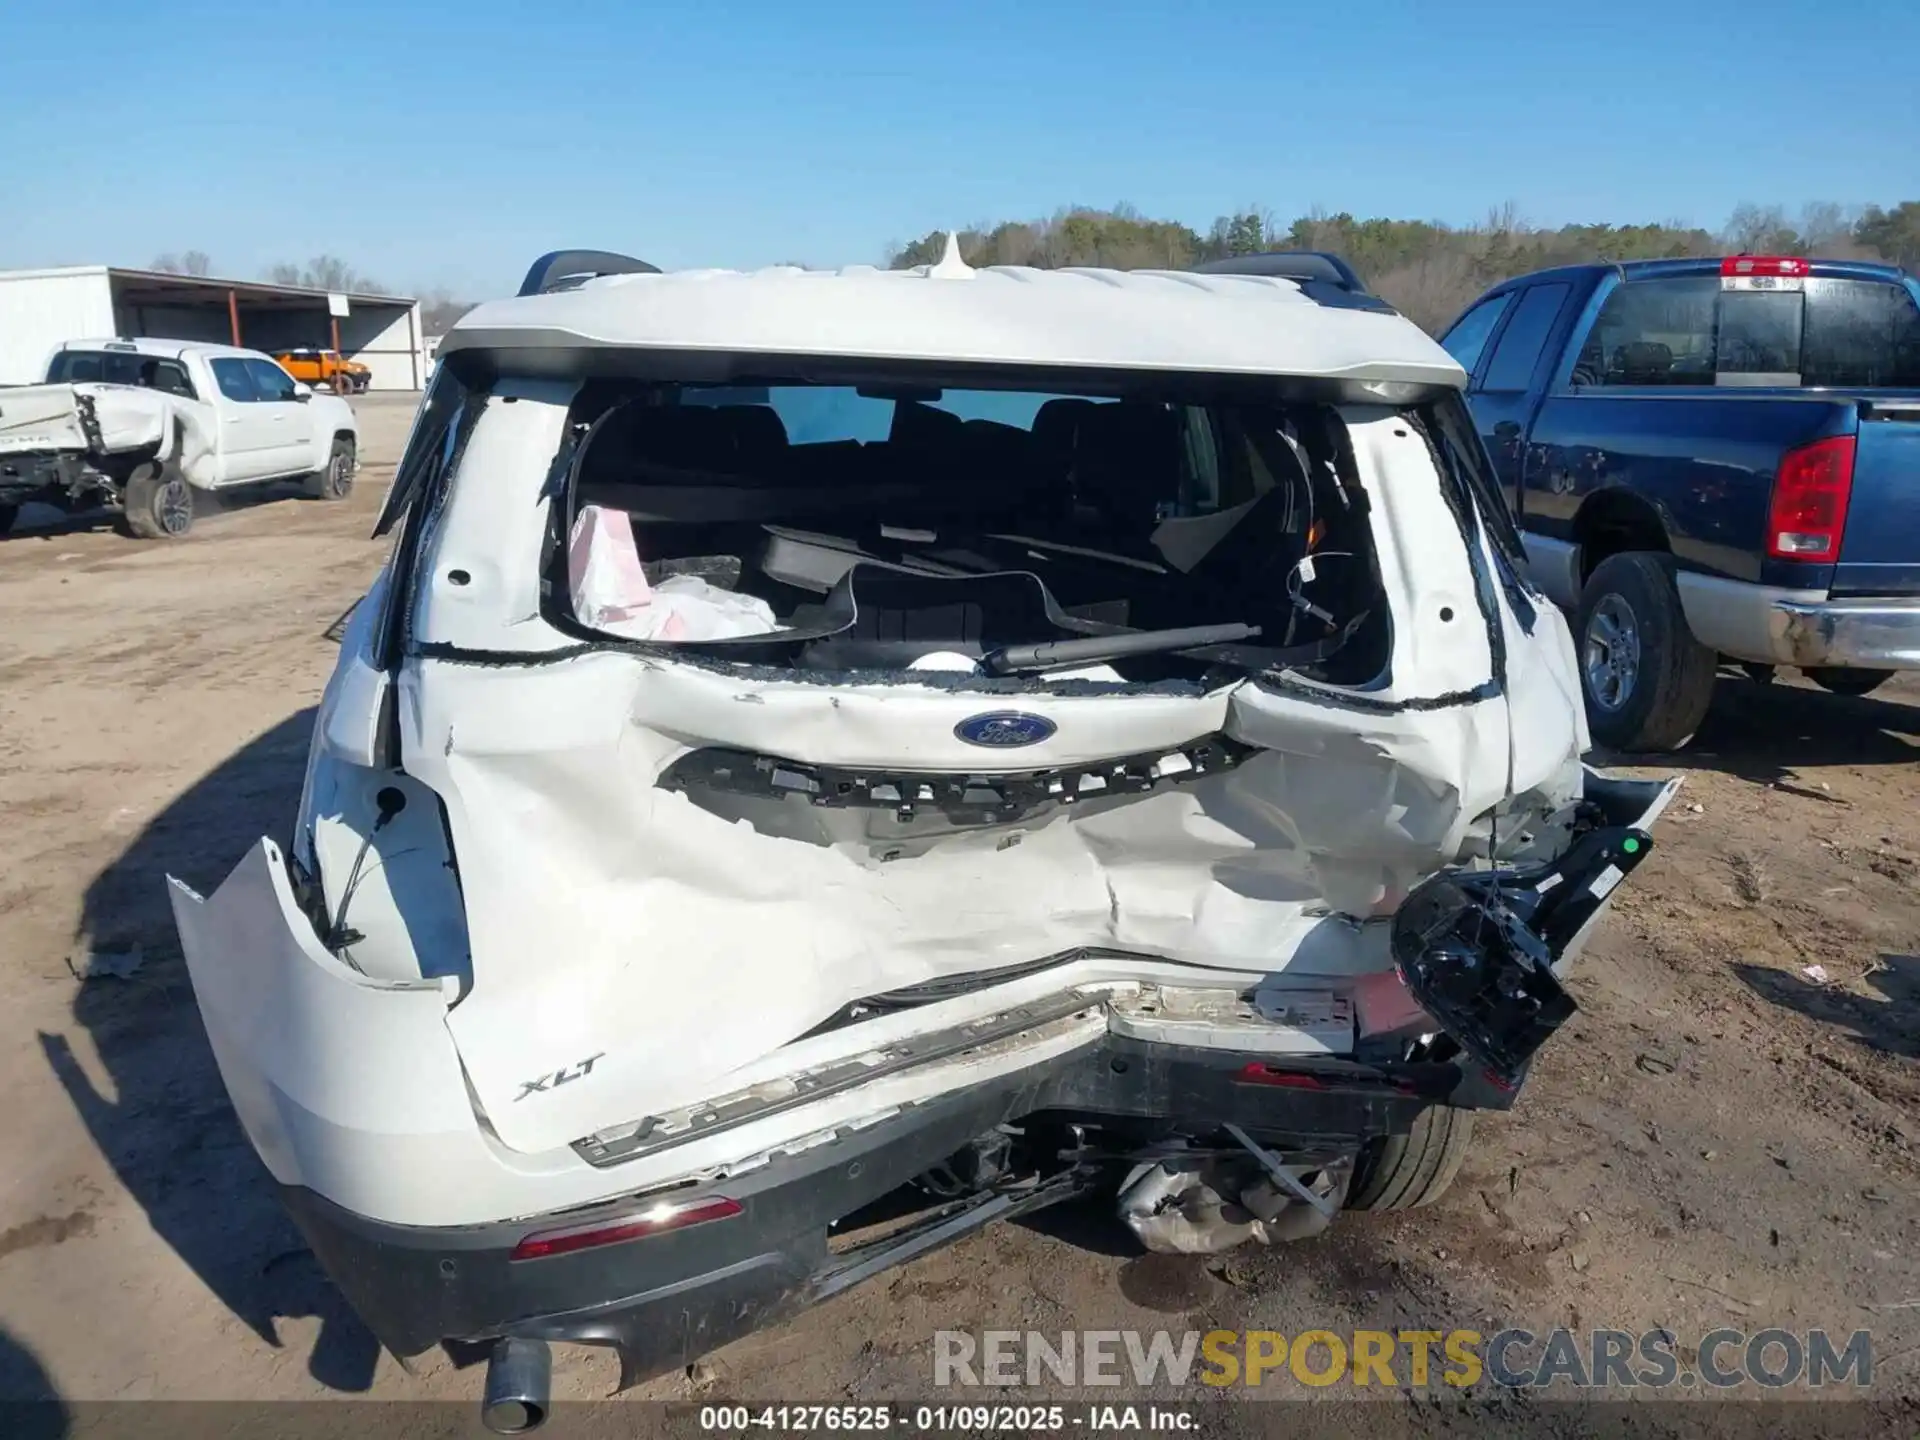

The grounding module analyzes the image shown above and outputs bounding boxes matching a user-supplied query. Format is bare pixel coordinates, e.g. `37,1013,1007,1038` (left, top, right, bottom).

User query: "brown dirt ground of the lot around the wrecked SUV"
0,397,1920,1427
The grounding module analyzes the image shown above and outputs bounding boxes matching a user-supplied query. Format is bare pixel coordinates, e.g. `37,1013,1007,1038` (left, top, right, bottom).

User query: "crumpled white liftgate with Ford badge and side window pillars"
357,384,1584,1152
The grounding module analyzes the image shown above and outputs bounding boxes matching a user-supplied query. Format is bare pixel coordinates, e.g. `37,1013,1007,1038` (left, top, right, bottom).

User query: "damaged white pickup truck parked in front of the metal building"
0,340,359,540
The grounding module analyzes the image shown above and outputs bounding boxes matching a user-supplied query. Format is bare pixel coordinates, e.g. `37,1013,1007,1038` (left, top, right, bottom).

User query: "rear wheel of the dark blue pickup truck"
1574,551,1718,751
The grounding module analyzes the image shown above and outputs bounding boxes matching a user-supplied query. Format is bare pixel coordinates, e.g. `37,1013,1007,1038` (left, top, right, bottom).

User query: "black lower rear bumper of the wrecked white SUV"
282,1037,1451,1384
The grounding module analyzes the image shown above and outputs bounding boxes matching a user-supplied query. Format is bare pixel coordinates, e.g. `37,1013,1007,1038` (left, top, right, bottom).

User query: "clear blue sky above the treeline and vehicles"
0,0,1920,296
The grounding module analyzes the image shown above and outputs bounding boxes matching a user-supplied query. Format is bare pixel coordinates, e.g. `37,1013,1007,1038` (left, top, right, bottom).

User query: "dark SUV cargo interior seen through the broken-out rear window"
549,380,1411,685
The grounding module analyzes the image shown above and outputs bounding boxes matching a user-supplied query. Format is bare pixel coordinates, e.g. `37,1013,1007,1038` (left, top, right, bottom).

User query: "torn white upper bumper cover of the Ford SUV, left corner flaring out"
171,841,1359,1225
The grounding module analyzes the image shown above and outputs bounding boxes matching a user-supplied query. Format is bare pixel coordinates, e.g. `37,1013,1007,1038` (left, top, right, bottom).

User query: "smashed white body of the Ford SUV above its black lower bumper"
175,275,1638,1225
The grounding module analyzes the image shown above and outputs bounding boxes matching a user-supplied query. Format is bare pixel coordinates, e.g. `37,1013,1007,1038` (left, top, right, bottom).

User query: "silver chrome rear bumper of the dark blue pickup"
1676,572,1920,670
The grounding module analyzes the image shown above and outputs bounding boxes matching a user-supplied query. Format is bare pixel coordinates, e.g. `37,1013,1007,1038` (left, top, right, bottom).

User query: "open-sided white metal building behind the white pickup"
0,265,426,390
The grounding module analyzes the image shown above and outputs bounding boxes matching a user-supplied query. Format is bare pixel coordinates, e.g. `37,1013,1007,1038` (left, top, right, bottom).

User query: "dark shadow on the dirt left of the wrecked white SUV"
40,707,378,1392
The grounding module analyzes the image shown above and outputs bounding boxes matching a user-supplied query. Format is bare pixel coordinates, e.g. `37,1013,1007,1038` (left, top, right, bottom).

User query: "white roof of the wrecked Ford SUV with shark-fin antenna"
440,253,1467,397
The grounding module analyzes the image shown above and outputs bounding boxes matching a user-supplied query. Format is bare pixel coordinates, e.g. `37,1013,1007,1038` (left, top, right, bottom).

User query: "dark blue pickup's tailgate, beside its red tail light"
1832,392,1920,595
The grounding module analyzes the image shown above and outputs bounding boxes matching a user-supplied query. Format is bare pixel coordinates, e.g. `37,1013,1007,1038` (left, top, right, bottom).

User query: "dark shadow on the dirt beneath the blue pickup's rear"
1605,676,1920,804
